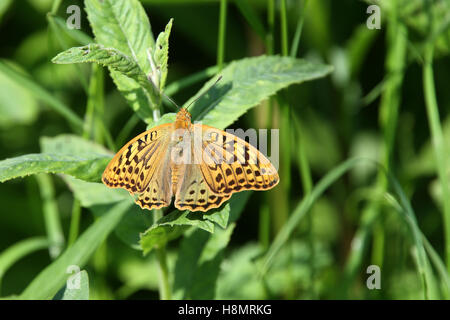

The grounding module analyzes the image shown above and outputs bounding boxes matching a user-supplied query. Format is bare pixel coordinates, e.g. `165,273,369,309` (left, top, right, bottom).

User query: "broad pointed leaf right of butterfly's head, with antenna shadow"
185,56,332,129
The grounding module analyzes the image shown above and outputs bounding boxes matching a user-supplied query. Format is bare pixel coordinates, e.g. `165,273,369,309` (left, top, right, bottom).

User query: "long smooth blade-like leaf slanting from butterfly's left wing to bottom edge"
20,202,131,300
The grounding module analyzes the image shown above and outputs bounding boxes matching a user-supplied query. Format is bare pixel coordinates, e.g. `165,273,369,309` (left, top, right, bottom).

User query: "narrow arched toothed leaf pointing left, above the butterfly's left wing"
52,43,155,96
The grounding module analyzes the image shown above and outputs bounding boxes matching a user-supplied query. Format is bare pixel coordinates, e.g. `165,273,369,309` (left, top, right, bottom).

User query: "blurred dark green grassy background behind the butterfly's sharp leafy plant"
0,0,450,299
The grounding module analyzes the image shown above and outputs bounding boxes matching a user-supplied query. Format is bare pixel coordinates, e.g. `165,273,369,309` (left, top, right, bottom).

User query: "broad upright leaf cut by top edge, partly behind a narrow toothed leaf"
85,0,157,123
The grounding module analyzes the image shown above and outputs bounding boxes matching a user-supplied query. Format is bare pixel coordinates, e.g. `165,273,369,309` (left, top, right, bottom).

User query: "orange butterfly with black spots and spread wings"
102,108,280,212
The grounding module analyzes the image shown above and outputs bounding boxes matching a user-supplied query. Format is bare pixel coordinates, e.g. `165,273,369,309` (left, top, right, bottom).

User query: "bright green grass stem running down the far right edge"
423,44,450,272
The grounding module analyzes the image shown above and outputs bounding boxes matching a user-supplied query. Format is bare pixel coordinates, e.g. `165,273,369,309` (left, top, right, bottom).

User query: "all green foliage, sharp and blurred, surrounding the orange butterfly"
0,0,450,299
